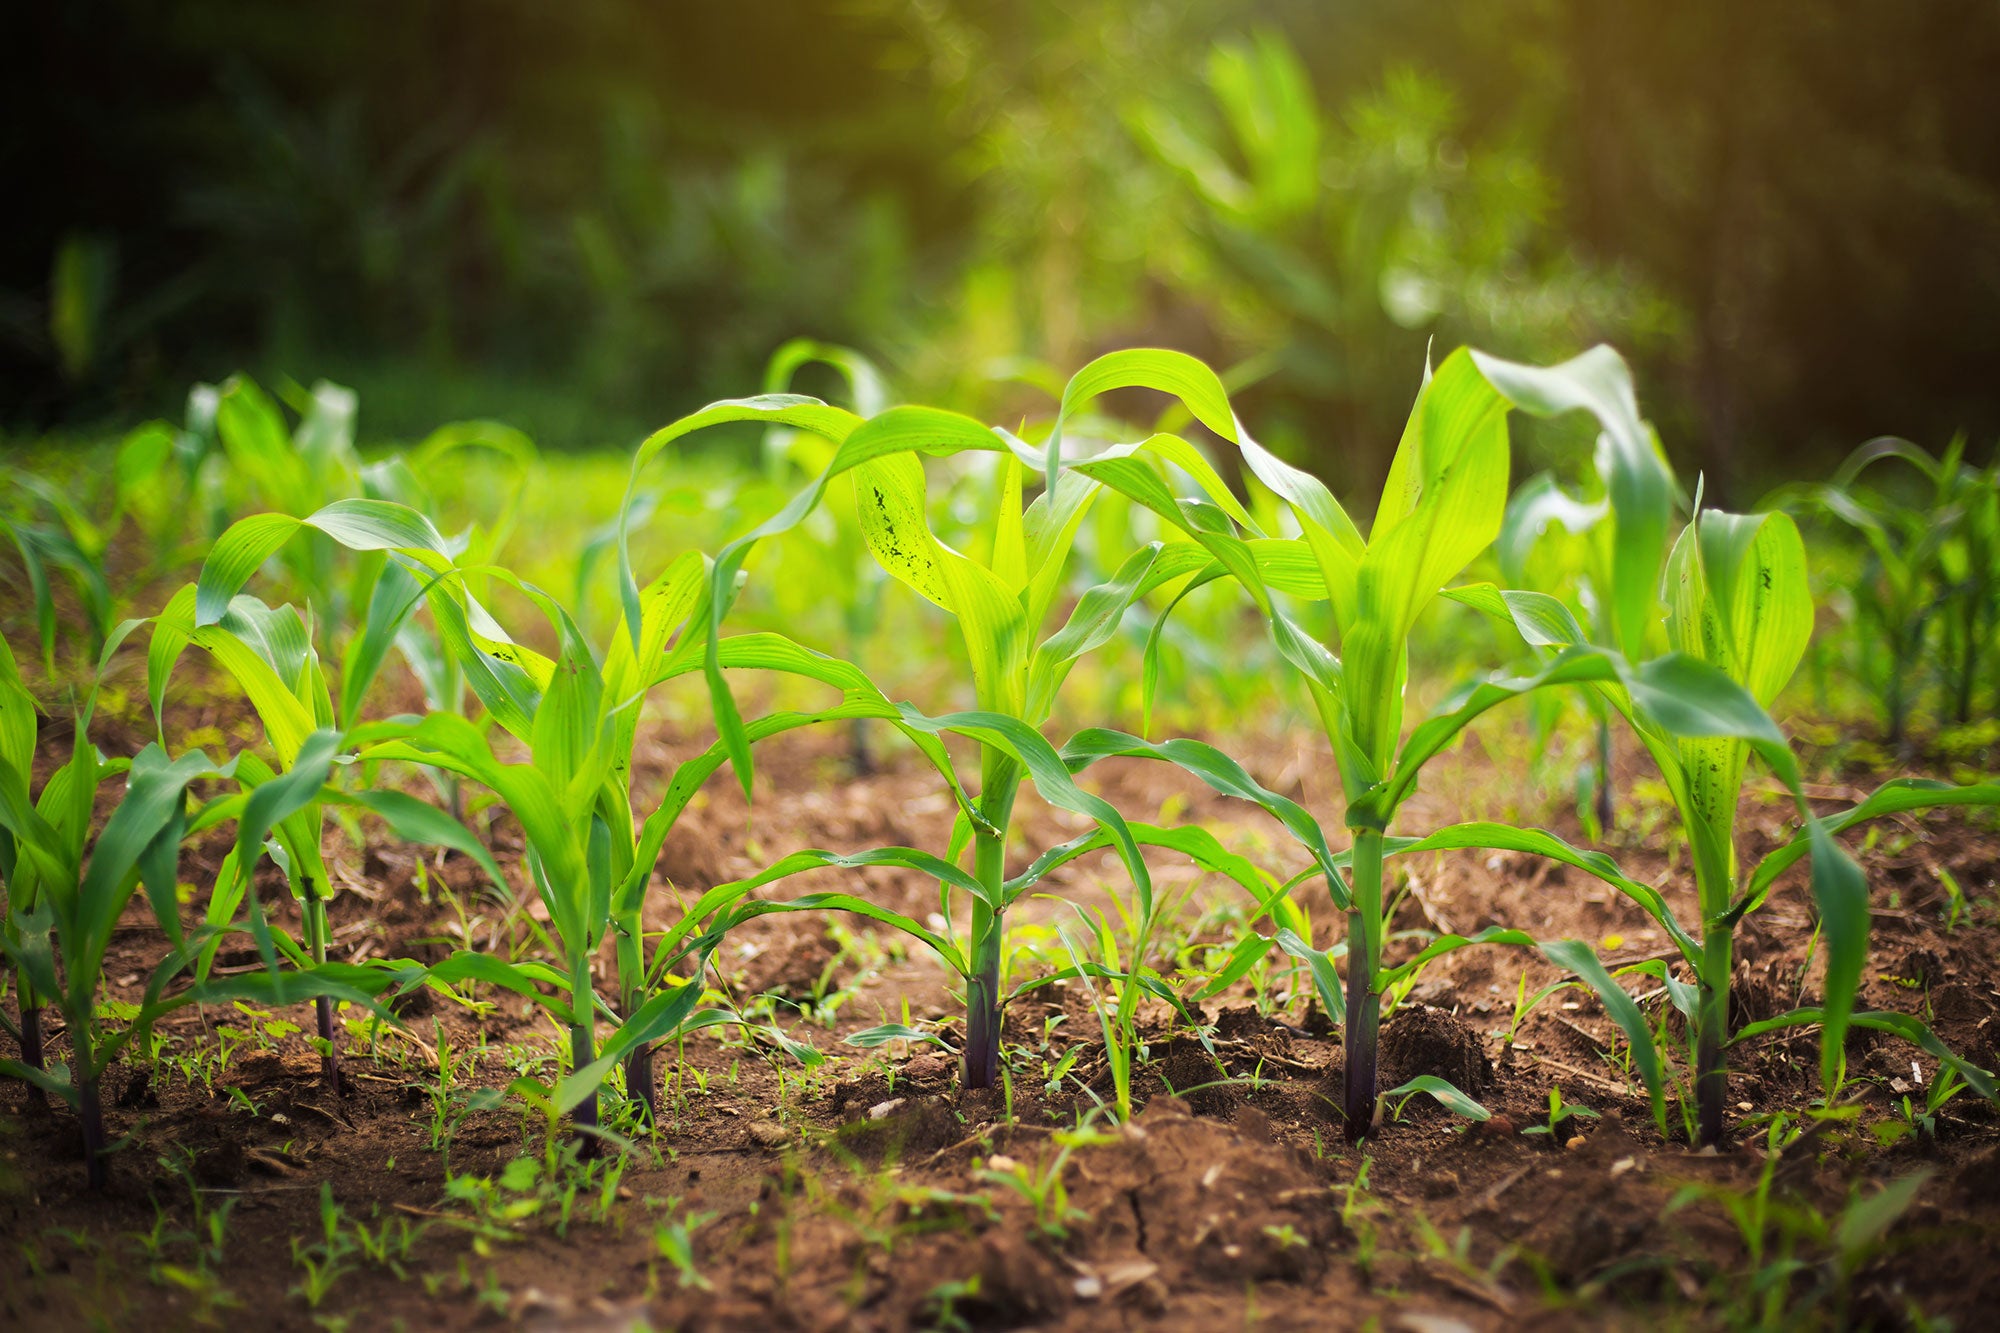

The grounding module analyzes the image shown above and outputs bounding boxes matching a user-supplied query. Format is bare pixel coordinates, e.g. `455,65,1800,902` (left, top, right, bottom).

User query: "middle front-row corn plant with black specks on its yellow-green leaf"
644,362,1328,1087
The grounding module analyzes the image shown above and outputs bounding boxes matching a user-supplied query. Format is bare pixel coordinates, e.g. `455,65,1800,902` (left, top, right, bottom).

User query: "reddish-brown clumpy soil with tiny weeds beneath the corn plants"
0,684,2000,1333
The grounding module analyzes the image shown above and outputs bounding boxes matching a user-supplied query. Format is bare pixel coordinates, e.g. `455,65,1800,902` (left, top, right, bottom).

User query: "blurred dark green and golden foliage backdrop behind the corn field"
11,0,2000,502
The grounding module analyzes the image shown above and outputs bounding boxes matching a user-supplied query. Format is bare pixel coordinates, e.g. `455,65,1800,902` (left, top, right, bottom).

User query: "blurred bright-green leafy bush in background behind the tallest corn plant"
1130,30,1672,492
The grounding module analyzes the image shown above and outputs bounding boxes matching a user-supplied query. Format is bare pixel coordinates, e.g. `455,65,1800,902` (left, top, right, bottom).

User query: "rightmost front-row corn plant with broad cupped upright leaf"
1424,378,2000,1145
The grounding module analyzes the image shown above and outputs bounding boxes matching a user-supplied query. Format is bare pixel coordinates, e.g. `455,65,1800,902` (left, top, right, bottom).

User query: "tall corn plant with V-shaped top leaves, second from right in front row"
1024,340,1726,1137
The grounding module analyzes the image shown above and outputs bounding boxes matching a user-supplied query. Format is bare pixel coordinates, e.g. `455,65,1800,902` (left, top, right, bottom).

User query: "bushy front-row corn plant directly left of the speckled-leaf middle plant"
192,500,988,1131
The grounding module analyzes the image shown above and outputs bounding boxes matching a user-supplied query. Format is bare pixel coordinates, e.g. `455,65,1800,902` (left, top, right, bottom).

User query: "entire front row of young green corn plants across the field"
0,344,2000,1183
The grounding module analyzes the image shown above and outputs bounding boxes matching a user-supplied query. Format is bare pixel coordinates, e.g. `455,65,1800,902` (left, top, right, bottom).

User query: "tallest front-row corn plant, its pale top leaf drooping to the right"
1066,338,1856,1137
